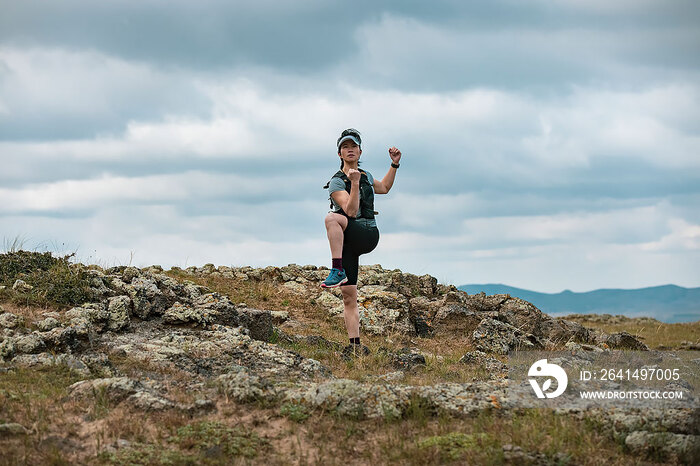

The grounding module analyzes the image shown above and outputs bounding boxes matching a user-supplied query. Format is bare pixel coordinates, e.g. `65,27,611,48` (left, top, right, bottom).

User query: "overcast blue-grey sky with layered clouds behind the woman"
0,0,700,292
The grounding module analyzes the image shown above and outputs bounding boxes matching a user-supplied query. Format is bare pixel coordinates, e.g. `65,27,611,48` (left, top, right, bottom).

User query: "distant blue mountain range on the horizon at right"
458,284,700,322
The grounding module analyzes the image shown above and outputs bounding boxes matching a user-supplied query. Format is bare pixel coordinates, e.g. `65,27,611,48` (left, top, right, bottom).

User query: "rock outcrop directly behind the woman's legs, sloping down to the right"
175,264,645,353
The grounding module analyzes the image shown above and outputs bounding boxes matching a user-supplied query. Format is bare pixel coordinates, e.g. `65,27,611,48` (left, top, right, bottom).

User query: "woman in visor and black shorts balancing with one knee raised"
321,128,401,357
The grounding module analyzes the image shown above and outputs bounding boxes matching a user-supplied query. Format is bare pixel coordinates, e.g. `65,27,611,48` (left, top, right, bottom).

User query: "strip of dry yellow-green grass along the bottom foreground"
0,368,672,465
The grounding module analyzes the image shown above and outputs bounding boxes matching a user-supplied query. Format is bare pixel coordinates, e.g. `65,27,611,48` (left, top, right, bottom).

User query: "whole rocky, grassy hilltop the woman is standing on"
0,253,700,464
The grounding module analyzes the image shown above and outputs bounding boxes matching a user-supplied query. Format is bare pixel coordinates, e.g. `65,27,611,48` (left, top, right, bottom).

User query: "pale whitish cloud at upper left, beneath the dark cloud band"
0,47,211,141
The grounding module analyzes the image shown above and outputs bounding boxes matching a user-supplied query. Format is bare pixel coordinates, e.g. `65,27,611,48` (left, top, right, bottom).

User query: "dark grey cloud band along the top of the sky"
0,0,700,75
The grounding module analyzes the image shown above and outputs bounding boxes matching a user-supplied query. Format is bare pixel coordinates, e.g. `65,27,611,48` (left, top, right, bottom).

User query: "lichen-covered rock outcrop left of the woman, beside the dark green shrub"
0,267,273,366
